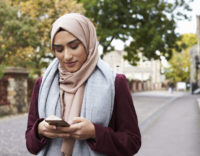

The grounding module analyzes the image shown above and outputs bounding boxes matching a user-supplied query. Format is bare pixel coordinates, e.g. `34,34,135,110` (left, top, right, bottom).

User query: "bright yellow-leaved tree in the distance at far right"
165,34,197,83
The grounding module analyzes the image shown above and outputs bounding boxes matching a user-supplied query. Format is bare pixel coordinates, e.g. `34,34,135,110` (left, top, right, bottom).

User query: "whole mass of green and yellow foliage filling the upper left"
0,0,84,76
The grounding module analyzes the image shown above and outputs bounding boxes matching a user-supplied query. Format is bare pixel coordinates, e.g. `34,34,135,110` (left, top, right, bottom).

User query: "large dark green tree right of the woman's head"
79,0,192,65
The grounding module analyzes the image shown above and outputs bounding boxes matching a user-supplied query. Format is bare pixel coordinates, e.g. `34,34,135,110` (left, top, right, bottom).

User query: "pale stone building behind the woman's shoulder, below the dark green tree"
103,50,162,90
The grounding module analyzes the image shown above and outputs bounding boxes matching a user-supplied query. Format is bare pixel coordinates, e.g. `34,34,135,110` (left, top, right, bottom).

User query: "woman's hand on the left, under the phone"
38,116,69,138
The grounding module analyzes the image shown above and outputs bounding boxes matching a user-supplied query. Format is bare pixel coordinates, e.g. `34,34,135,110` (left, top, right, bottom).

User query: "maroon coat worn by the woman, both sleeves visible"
26,74,141,156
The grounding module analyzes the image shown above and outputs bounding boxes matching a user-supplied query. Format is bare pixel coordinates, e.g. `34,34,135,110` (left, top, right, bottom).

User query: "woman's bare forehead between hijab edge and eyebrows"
53,30,76,44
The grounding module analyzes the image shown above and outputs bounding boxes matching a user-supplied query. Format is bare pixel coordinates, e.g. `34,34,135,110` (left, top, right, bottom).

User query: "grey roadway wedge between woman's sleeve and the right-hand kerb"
132,91,190,132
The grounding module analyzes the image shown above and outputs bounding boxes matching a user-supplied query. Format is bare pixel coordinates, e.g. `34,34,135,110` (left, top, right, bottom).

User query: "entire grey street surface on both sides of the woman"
0,91,200,156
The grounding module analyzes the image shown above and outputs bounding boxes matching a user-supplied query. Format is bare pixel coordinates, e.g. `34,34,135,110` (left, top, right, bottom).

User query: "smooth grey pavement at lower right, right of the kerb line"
136,94,200,156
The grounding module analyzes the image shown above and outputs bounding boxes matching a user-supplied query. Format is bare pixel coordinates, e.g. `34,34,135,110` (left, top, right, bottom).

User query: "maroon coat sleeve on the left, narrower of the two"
25,78,48,154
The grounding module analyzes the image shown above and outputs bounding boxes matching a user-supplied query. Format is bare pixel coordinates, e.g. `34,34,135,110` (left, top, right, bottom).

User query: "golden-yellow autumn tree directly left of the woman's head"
0,0,84,76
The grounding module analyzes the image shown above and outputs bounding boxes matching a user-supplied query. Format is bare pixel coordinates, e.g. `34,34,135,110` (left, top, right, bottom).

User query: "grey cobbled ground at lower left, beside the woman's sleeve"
0,114,33,156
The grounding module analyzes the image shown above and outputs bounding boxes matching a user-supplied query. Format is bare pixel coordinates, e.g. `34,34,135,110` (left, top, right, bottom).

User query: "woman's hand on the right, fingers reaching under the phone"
57,117,96,140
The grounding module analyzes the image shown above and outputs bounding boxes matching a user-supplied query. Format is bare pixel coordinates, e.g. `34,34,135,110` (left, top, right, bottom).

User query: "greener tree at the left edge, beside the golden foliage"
0,0,38,76
